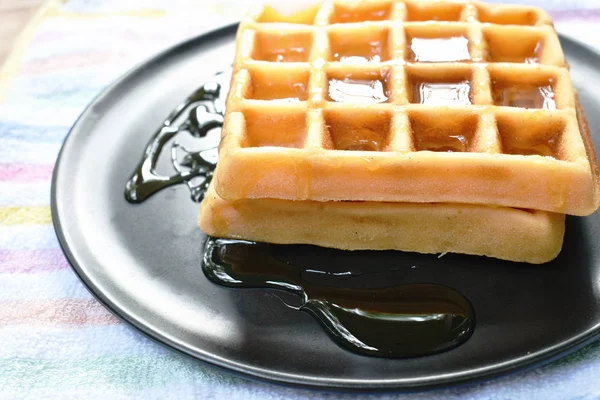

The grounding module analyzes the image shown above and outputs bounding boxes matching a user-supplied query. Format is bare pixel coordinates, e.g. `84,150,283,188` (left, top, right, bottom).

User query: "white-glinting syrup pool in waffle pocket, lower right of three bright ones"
412,81,471,105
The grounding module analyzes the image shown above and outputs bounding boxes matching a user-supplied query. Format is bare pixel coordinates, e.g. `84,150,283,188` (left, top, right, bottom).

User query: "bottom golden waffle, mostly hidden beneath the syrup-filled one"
199,182,565,264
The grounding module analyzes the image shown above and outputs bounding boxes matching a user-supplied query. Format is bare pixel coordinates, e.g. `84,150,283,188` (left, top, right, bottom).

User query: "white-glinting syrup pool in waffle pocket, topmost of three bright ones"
409,36,471,62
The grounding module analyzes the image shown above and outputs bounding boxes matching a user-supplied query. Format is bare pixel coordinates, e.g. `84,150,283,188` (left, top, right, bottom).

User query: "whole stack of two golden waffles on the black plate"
199,0,600,263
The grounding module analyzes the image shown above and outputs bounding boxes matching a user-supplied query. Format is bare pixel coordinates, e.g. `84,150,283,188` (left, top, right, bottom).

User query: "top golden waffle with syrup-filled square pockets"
216,0,600,215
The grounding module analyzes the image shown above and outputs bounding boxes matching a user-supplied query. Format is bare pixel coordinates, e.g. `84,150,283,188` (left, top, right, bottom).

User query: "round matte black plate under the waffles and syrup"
52,26,600,389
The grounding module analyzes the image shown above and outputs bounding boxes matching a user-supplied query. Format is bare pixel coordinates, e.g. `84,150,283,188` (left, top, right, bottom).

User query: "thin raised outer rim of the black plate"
50,22,600,392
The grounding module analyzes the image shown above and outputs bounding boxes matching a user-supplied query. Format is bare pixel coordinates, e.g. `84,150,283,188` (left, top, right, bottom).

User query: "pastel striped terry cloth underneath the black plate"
0,0,600,399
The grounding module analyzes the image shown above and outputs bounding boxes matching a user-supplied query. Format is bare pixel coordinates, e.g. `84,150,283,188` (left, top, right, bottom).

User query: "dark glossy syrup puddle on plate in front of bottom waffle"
202,238,475,358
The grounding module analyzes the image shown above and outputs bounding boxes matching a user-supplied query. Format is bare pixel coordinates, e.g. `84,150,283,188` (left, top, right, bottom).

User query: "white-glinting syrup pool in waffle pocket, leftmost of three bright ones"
328,78,388,104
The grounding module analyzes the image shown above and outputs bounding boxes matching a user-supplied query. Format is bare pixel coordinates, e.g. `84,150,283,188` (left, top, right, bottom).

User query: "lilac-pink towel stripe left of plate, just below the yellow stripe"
0,249,69,274
